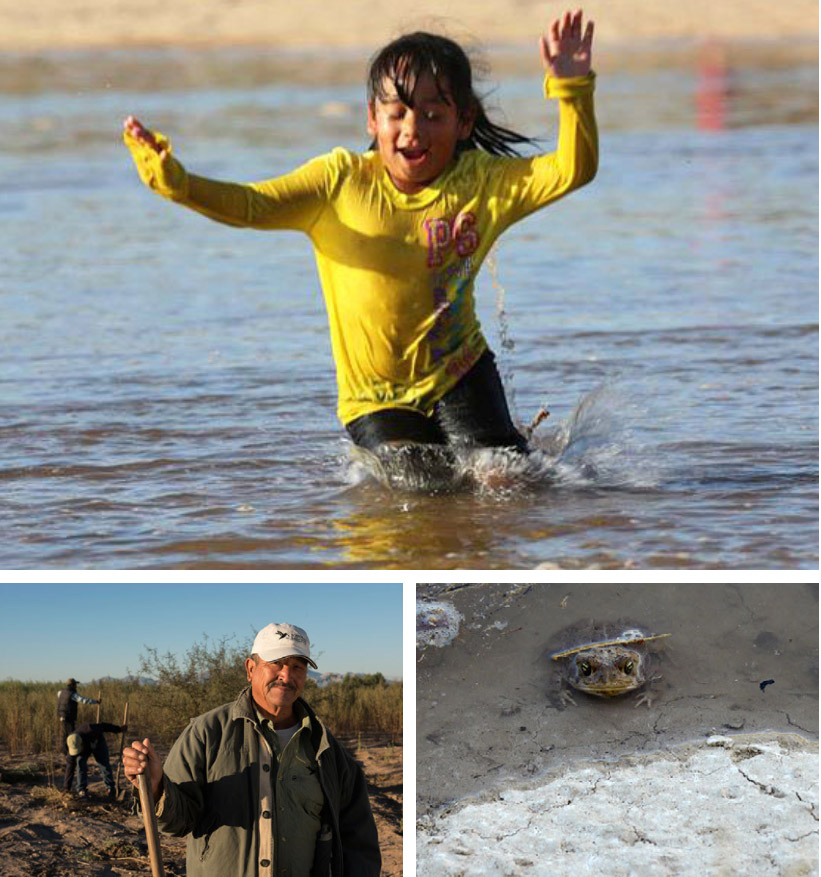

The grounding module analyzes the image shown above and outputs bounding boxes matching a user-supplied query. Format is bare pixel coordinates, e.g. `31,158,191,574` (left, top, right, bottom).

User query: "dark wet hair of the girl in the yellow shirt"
368,31,535,155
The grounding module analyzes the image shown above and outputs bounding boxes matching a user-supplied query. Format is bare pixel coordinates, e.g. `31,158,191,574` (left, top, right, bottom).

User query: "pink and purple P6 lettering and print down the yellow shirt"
425,211,480,363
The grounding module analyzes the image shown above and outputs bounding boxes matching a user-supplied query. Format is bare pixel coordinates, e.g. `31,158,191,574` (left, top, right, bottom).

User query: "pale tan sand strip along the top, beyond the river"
0,0,818,51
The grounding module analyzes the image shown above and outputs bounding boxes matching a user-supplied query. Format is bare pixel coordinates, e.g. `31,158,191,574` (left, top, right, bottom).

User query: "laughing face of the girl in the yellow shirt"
368,73,473,195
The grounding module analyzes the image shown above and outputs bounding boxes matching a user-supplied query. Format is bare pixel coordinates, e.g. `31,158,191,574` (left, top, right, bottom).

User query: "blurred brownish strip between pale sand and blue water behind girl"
0,35,818,94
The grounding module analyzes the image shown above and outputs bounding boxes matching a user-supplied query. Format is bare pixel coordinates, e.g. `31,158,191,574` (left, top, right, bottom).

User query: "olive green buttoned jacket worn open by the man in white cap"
156,687,381,877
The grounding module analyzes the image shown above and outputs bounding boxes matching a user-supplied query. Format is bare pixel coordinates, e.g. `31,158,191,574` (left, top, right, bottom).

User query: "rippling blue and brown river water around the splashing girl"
0,50,818,569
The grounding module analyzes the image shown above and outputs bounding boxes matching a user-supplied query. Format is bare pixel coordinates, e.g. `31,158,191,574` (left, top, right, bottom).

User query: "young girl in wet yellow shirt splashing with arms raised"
124,11,598,480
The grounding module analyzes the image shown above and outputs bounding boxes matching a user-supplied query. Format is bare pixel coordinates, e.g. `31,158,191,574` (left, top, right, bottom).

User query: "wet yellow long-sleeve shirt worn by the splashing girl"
125,74,598,423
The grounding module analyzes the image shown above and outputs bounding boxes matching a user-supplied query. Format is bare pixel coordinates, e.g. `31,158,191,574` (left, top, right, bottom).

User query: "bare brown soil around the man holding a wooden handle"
0,739,402,877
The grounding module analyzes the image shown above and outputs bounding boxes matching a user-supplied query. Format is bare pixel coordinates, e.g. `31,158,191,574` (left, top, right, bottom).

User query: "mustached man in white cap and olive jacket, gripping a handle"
123,622,381,877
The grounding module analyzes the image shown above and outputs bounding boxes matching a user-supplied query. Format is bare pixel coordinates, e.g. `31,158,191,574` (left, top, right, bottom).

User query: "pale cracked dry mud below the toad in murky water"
417,735,818,877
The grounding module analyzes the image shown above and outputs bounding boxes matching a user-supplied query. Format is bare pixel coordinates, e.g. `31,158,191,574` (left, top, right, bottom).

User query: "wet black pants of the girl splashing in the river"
346,350,527,452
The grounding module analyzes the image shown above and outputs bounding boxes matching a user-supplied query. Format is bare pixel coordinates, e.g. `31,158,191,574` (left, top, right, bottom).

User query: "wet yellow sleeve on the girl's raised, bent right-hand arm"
486,73,599,225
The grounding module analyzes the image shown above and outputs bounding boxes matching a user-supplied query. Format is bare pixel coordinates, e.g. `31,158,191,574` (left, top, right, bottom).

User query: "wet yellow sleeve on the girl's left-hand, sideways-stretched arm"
123,132,332,232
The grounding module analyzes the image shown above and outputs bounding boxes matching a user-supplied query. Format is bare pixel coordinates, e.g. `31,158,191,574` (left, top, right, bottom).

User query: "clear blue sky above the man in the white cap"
0,582,402,680
